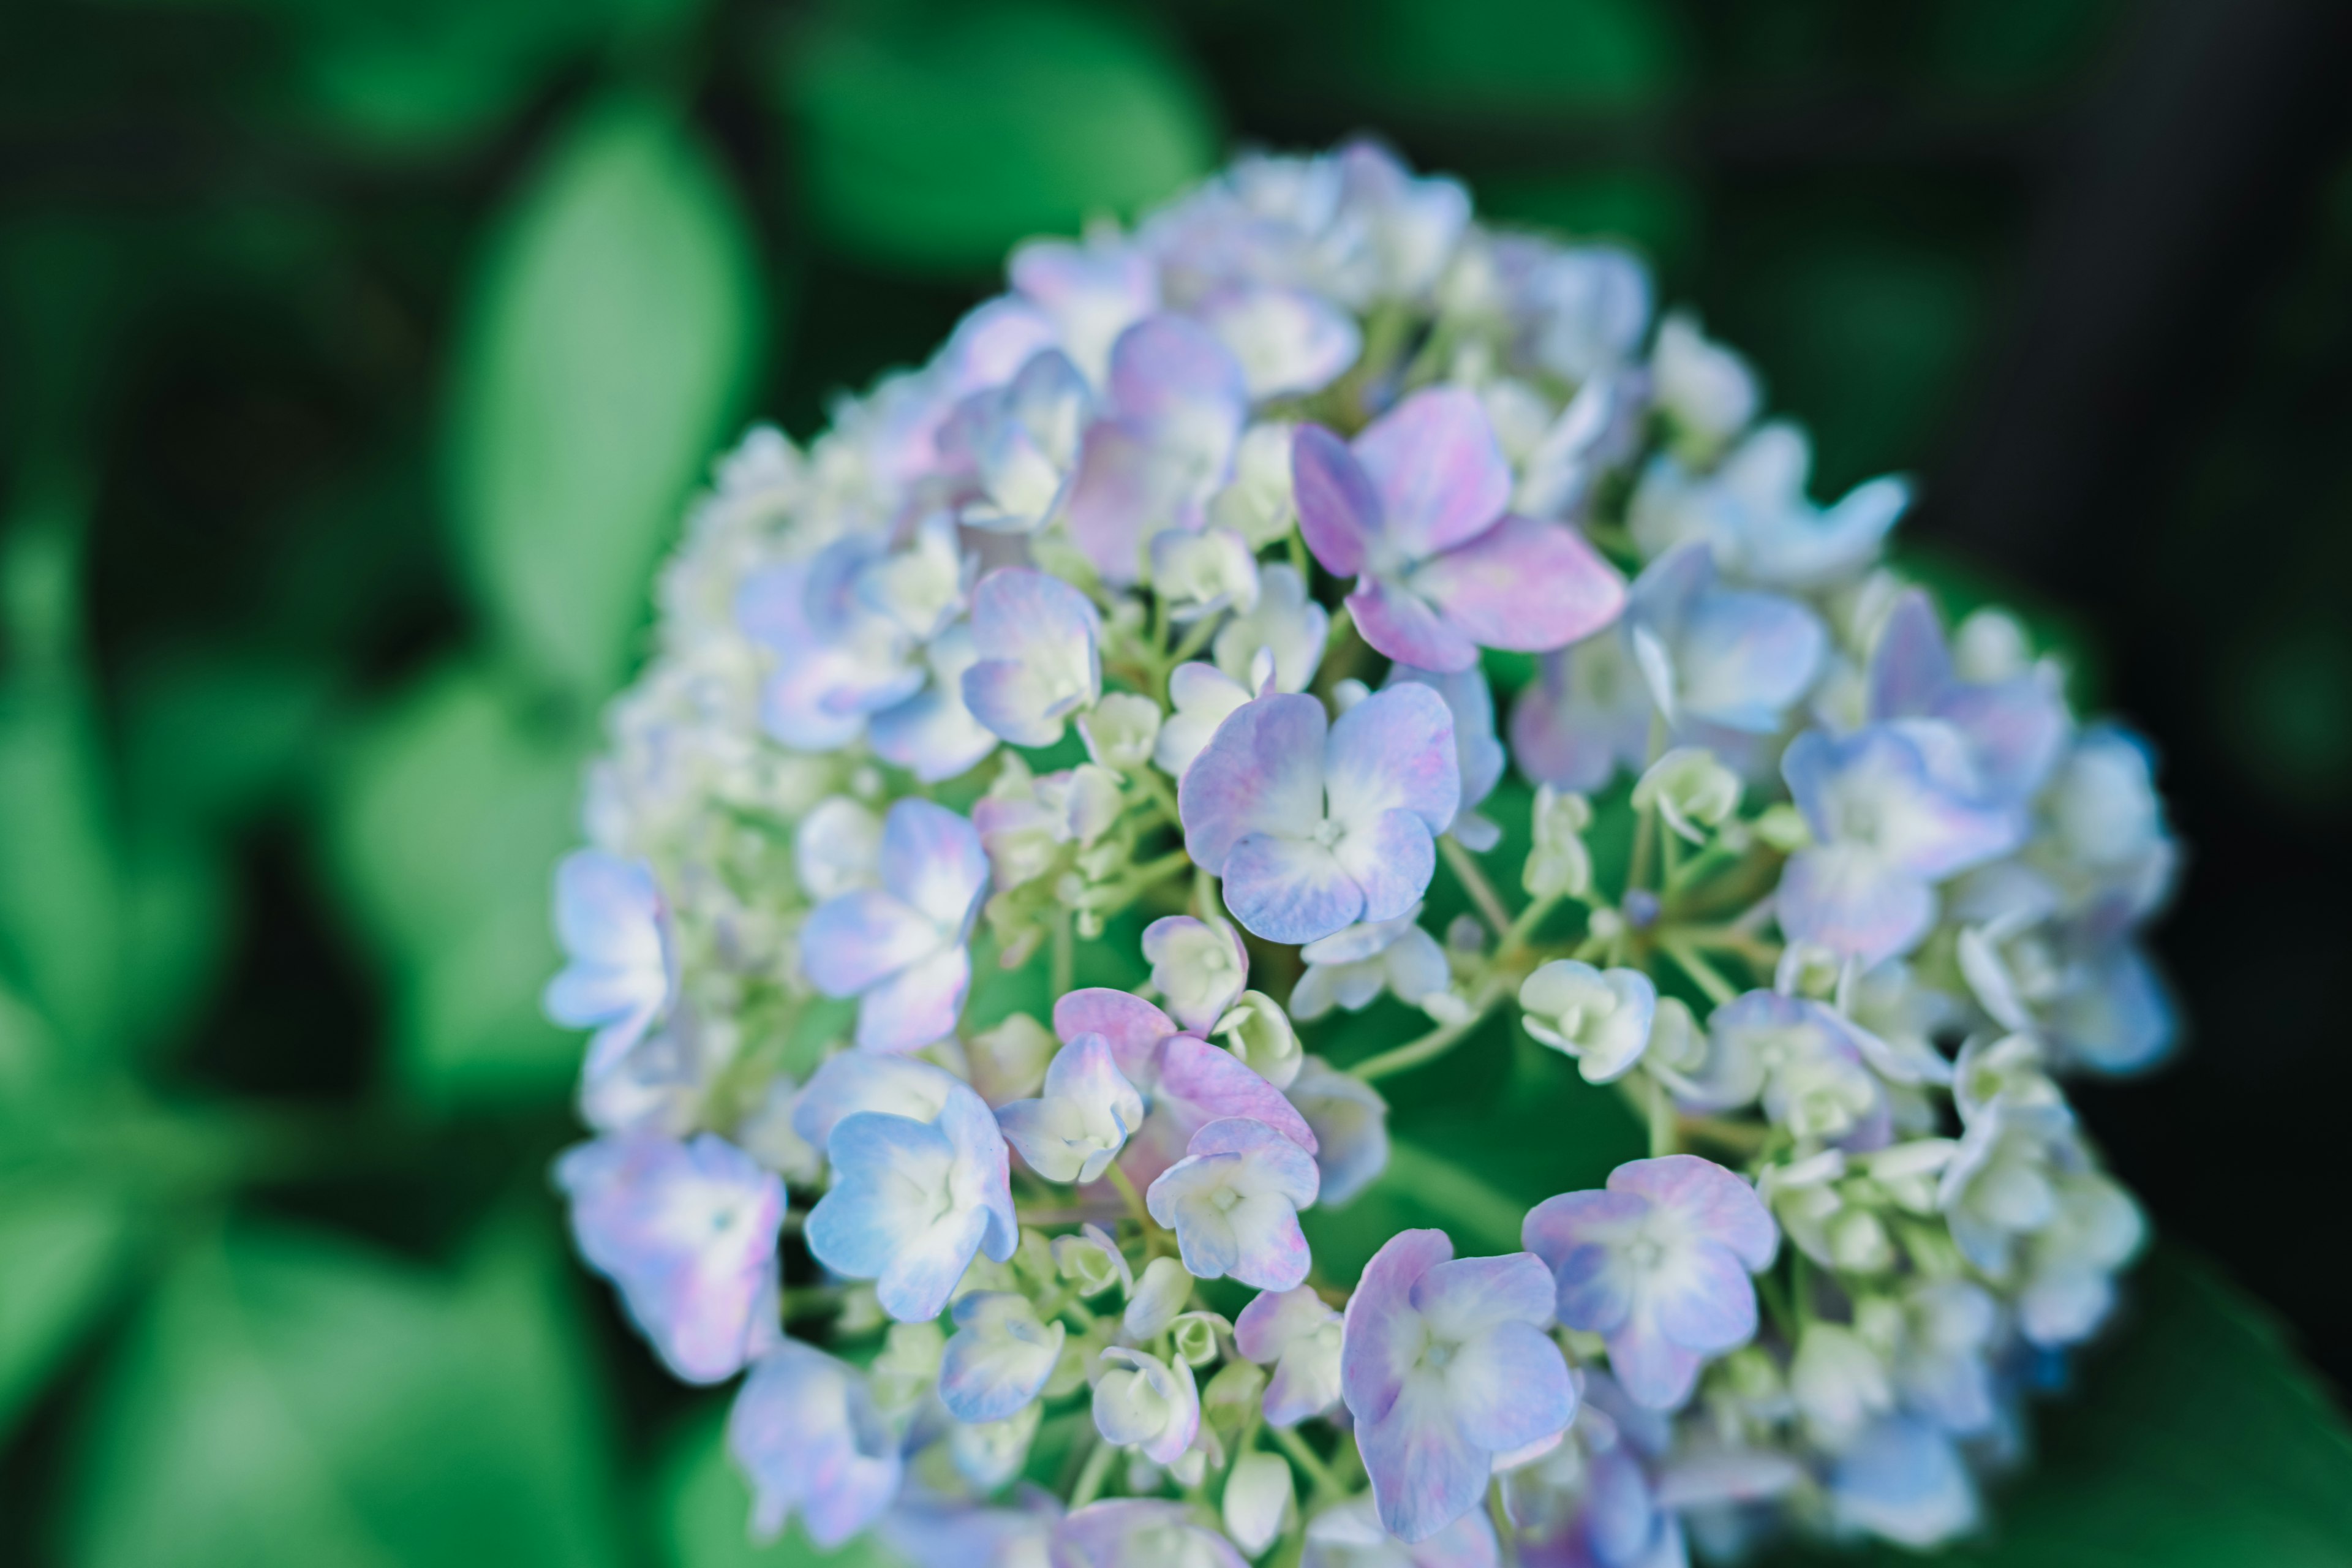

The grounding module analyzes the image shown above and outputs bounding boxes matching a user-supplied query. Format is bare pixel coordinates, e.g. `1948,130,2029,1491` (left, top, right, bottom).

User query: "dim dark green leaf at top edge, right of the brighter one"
1343,0,1686,113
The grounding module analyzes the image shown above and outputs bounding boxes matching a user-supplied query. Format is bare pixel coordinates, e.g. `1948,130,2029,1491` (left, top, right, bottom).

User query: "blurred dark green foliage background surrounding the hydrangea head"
0,0,2352,1568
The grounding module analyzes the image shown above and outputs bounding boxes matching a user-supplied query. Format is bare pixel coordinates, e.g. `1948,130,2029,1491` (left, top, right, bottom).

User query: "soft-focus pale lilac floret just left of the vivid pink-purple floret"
1063,315,1249,586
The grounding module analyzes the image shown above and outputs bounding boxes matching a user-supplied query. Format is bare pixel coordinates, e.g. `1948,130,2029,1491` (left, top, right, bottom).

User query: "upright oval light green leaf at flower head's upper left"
447,96,764,701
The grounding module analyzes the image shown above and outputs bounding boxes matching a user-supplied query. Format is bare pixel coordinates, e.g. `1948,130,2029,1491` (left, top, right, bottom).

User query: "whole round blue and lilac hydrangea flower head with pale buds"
548,146,2176,1568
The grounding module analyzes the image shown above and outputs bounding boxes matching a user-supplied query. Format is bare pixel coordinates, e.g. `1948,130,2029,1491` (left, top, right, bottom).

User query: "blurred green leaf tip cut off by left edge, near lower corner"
0,1183,132,1436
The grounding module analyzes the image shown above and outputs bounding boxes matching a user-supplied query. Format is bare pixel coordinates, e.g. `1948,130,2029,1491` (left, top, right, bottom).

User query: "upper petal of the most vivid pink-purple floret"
1355,385,1510,564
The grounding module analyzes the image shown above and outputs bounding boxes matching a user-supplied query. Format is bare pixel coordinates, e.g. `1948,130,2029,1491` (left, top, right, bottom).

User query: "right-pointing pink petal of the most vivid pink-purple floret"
1411,517,1625,654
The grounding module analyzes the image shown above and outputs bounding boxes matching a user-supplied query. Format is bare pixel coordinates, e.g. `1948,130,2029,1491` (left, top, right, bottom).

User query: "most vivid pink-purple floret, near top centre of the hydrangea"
1291,388,1625,670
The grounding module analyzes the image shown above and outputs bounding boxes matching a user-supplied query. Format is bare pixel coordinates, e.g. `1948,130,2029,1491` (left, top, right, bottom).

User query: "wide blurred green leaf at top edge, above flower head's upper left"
781,0,1218,270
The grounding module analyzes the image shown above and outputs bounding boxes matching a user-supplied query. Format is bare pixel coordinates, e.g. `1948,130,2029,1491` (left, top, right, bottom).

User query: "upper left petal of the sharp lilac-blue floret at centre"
1176,691,1329,877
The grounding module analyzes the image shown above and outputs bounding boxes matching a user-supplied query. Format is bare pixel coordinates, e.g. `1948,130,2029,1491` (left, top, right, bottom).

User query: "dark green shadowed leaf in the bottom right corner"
1776,1248,2352,1568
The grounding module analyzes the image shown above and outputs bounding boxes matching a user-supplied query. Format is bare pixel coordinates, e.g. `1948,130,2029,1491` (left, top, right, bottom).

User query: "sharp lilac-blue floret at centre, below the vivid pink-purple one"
1176,684,1461,943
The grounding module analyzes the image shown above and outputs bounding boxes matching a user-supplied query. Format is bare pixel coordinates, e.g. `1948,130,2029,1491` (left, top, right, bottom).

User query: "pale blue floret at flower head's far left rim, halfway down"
541,849,677,1086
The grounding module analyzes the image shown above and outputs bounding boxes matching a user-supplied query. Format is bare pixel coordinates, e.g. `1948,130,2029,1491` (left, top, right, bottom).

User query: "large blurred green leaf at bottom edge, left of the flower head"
66,1227,621,1568
